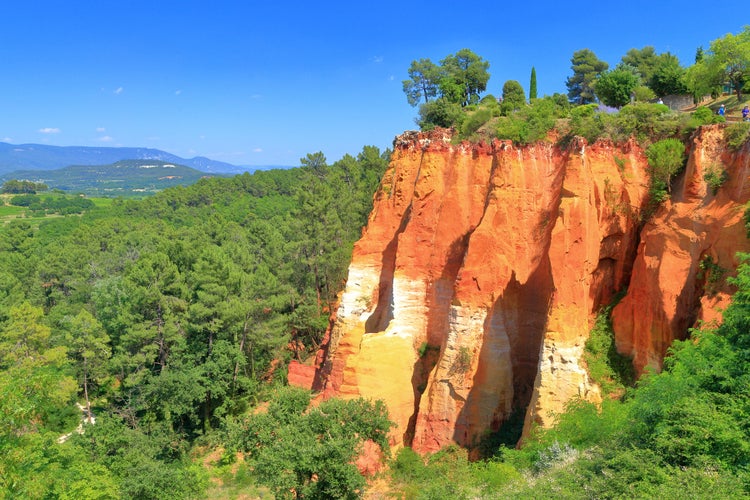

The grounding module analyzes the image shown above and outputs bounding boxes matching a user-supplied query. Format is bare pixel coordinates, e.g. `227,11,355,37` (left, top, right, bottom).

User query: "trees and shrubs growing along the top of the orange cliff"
403,27,750,145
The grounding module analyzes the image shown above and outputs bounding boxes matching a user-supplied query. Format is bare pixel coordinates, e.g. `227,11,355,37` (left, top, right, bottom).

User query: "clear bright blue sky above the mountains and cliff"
0,0,743,166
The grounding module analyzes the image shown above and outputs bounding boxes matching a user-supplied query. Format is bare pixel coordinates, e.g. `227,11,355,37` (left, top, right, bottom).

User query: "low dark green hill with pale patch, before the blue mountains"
0,160,223,196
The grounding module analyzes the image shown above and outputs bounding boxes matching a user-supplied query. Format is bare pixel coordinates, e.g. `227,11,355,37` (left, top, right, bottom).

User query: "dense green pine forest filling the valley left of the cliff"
0,146,390,498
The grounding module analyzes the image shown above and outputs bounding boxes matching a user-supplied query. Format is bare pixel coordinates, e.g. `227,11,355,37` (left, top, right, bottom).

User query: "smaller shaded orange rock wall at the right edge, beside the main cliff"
612,125,750,372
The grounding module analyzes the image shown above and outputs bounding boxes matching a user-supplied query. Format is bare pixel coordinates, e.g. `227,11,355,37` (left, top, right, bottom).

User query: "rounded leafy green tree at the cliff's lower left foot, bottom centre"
227,388,392,498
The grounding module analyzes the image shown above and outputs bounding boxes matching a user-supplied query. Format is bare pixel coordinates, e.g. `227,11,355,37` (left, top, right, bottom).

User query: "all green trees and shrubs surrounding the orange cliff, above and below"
0,28,750,499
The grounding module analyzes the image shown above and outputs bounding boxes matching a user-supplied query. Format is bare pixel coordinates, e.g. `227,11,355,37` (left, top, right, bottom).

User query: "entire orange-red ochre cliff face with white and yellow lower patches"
319,129,748,451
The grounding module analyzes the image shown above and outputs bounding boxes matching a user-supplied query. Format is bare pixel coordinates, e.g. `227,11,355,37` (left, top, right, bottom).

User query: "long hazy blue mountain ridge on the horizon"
0,142,256,175
